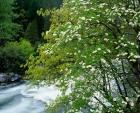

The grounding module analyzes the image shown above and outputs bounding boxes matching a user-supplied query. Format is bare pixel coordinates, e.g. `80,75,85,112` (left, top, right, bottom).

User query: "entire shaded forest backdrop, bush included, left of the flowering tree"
0,0,62,74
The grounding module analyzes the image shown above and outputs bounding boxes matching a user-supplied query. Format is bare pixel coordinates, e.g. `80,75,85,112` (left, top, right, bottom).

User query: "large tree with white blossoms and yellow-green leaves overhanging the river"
28,0,140,113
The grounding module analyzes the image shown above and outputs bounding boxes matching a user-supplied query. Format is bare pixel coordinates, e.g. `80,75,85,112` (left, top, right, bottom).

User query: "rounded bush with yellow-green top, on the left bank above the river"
0,39,34,74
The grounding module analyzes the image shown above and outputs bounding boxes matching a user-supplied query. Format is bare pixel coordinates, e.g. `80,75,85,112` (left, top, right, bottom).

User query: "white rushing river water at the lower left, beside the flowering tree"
0,84,60,113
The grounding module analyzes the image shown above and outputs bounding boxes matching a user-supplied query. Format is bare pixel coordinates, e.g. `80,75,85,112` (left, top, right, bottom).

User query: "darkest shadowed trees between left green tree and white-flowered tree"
14,0,62,47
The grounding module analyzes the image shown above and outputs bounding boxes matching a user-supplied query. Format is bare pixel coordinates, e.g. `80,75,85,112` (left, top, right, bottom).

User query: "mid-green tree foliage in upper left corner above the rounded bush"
0,0,19,40
